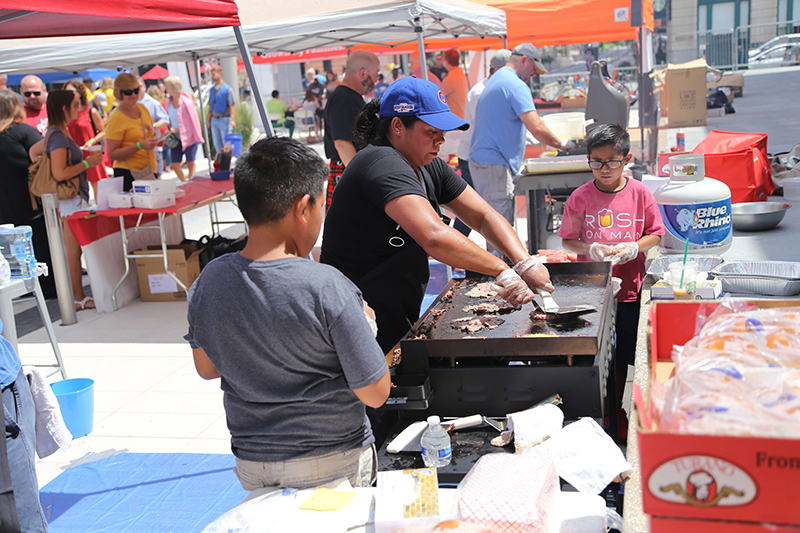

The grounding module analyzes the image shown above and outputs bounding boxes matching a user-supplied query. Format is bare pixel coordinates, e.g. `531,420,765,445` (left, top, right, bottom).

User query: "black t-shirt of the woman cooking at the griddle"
320,139,467,285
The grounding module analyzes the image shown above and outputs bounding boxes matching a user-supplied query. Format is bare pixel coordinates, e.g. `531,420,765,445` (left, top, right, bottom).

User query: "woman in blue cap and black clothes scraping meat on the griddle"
320,77,553,352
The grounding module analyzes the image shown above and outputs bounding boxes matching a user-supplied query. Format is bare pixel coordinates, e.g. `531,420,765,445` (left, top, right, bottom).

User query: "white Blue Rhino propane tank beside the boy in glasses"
653,154,733,255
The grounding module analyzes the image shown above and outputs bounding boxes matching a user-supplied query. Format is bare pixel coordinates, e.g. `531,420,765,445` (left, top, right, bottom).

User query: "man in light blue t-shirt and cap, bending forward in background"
469,43,571,235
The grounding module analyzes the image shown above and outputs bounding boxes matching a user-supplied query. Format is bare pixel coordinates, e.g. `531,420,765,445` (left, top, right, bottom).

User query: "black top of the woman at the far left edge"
0,123,42,225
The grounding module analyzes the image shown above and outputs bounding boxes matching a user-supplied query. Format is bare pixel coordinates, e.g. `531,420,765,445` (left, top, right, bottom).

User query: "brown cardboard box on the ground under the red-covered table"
133,244,200,302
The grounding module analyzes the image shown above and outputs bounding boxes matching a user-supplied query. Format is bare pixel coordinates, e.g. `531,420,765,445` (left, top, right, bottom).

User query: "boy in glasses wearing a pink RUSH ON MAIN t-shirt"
558,124,664,434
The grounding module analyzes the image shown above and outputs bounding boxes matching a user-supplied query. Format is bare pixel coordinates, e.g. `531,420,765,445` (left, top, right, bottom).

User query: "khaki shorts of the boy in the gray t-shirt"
233,444,378,491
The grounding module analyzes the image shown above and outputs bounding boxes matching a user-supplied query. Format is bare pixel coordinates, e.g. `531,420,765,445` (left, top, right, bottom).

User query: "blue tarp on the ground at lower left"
39,453,248,533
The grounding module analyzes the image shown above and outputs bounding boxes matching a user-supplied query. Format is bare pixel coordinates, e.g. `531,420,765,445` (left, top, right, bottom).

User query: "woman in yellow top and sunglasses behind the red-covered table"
106,72,164,191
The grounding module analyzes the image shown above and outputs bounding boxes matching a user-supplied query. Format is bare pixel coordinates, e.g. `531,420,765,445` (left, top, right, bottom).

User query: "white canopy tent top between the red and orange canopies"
0,0,506,131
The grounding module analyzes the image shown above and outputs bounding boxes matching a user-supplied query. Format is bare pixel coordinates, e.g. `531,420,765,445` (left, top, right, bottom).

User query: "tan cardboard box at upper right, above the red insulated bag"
654,58,708,128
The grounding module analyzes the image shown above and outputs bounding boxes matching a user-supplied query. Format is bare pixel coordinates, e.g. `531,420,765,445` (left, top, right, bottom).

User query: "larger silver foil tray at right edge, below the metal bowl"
711,261,800,296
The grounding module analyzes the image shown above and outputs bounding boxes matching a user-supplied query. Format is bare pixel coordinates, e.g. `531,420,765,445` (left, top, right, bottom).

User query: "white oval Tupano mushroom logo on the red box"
647,455,758,507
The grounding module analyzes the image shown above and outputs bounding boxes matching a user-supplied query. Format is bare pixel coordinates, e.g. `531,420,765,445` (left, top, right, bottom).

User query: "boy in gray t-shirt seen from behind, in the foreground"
185,137,390,490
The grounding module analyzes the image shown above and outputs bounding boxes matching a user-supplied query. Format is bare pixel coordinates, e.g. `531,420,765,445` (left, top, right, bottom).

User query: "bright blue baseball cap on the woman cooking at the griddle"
378,76,469,131
